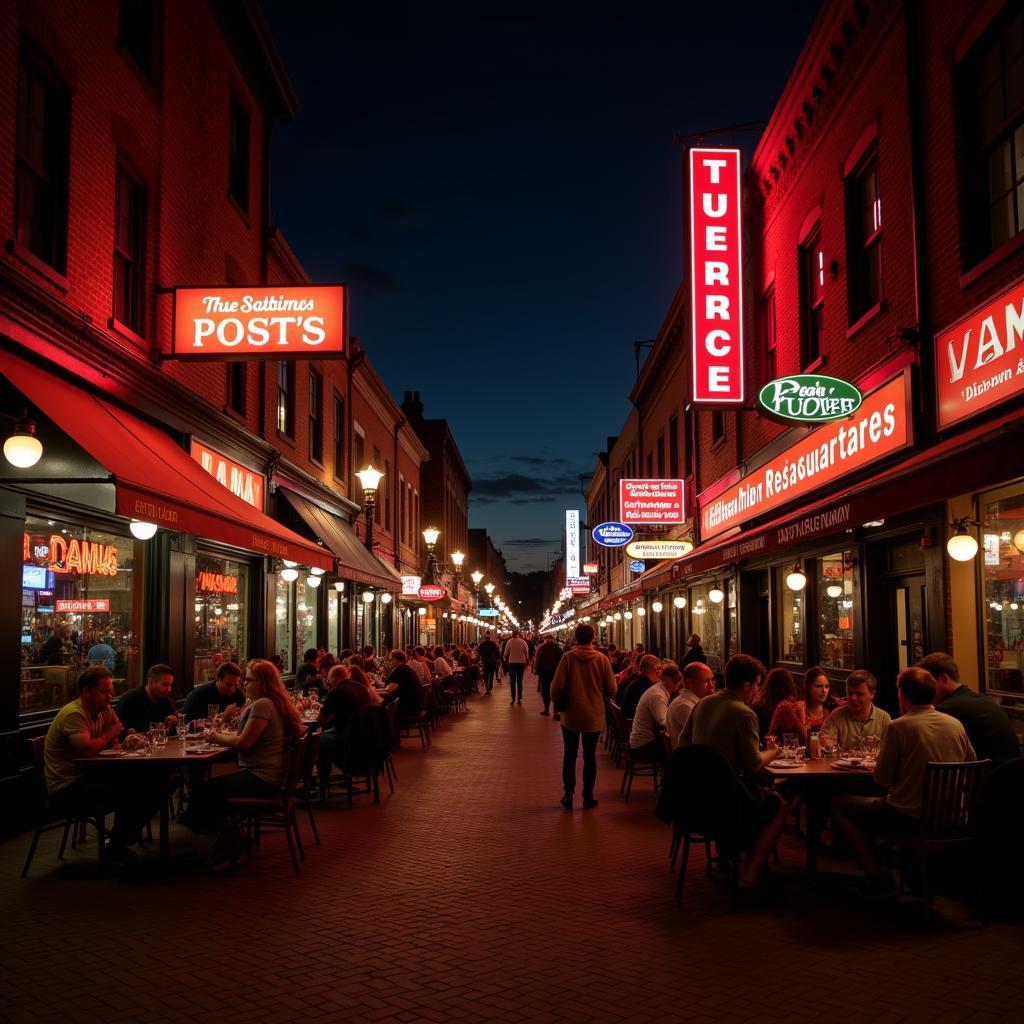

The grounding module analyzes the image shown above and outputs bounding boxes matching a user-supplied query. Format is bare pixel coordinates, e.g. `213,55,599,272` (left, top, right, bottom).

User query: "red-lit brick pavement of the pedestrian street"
0,679,1024,1024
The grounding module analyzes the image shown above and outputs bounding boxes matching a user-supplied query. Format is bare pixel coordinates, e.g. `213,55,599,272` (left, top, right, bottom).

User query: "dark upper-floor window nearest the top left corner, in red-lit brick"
14,47,71,273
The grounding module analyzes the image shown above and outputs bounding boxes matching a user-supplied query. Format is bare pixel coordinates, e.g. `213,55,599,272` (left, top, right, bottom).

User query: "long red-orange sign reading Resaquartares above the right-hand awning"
698,370,912,541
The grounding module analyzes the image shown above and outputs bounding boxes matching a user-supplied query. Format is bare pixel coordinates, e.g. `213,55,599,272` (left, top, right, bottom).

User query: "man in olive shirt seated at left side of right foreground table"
679,654,790,894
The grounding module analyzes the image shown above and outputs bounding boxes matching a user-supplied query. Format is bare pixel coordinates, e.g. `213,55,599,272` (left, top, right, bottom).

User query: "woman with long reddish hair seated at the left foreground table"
204,659,306,870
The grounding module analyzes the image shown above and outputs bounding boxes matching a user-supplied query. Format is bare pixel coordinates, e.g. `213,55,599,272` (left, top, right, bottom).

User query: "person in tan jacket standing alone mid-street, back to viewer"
551,623,615,811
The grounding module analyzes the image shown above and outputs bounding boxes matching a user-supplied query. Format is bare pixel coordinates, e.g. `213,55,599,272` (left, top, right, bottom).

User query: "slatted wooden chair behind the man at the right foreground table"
884,761,992,925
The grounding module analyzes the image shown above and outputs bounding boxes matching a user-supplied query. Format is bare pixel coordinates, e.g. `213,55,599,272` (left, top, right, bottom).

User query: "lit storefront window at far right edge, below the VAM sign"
978,486,1024,693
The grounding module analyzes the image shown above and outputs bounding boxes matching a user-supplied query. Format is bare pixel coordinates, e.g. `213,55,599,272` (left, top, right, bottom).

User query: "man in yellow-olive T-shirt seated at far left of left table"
43,665,159,863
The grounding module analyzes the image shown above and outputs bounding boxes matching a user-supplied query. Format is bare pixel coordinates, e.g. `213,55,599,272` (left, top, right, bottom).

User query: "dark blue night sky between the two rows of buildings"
264,0,820,571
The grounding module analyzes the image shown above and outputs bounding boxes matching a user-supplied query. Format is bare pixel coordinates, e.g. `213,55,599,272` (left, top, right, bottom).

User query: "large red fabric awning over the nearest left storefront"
0,351,334,570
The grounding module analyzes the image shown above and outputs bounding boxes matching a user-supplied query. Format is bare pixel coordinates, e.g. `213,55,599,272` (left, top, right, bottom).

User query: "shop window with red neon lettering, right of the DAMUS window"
193,555,249,686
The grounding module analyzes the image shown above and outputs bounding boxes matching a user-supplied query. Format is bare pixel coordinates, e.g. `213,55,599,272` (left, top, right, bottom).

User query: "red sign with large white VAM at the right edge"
935,278,1024,430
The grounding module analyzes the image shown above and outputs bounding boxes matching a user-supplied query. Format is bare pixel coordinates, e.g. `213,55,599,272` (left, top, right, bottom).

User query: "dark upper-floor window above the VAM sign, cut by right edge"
962,4,1024,262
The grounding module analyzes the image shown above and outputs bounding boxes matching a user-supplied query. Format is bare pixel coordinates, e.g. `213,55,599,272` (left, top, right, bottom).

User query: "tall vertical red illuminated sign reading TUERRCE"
688,148,743,403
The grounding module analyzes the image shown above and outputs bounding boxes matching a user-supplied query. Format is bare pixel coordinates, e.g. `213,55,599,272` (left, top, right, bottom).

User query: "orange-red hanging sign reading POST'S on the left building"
165,285,346,359
